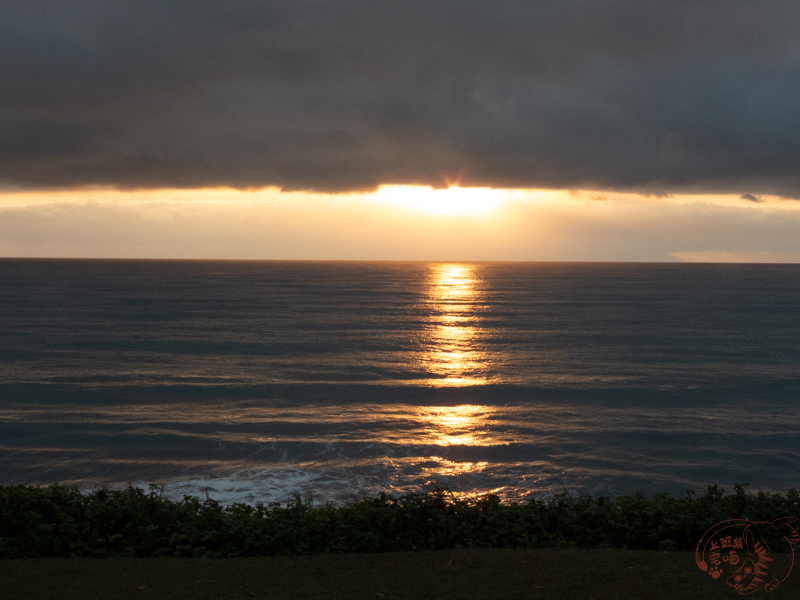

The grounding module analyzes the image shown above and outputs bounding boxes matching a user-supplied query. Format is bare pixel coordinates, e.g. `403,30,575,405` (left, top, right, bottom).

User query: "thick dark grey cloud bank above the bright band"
0,0,800,197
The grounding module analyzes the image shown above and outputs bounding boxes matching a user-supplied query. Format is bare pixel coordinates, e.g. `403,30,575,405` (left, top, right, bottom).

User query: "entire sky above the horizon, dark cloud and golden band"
0,0,800,262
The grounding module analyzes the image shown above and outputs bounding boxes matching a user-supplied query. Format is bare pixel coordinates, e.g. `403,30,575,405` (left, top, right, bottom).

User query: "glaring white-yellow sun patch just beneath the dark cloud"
370,185,508,216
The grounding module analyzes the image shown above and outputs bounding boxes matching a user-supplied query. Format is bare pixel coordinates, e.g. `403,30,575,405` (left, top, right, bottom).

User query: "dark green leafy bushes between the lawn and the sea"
0,484,800,558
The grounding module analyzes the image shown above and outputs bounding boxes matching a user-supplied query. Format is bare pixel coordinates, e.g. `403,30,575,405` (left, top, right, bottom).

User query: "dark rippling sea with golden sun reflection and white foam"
0,259,800,504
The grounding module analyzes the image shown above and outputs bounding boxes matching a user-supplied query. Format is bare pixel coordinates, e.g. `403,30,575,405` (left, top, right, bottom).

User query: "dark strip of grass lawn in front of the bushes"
0,549,800,600
